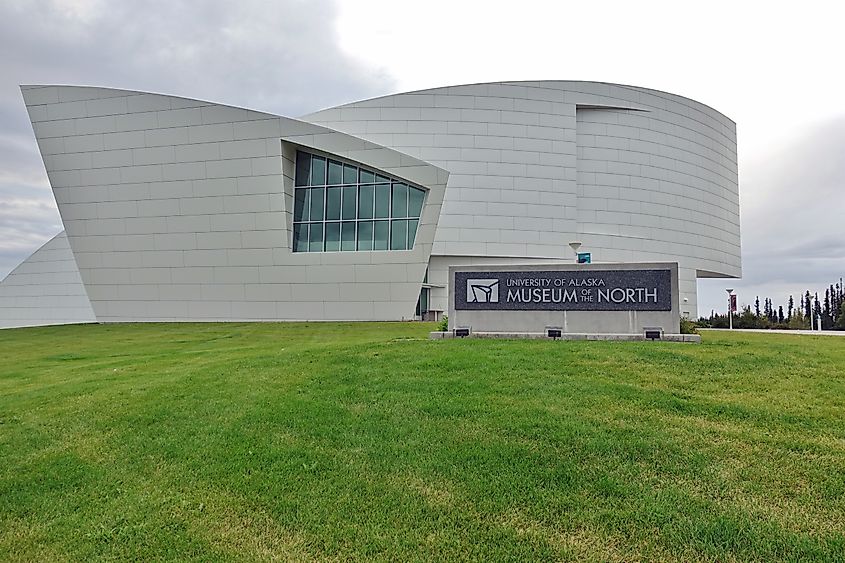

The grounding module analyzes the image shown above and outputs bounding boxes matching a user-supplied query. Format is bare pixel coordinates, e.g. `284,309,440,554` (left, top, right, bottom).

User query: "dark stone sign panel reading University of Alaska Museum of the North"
453,270,672,311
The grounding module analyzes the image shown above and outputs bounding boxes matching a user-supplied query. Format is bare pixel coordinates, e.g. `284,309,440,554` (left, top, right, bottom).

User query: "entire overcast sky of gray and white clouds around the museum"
0,0,845,314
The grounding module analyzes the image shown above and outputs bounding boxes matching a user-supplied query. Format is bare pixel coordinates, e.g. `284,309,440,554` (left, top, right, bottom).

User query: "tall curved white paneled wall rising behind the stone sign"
304,81,741,315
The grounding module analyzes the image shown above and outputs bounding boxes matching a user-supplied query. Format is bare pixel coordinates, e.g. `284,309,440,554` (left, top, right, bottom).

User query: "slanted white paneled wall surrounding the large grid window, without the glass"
22,86,448,322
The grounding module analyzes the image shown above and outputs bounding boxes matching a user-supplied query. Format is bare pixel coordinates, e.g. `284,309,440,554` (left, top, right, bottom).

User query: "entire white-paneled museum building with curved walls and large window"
0,81,741,327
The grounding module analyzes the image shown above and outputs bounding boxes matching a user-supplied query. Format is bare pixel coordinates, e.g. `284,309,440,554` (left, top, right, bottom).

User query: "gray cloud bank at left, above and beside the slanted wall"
0,0,394,279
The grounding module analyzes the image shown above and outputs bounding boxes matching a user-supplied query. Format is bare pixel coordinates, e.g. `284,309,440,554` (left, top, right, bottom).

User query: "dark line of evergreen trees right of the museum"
696,278,845,330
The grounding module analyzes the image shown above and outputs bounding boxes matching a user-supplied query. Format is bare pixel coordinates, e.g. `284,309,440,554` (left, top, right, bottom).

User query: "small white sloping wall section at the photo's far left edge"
0,232,97,328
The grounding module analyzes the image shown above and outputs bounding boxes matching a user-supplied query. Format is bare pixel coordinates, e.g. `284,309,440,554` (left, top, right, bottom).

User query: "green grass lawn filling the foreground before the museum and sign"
0,323,845,561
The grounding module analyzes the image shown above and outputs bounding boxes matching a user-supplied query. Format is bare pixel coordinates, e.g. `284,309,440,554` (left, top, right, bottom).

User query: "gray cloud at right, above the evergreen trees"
699,118,845,315
